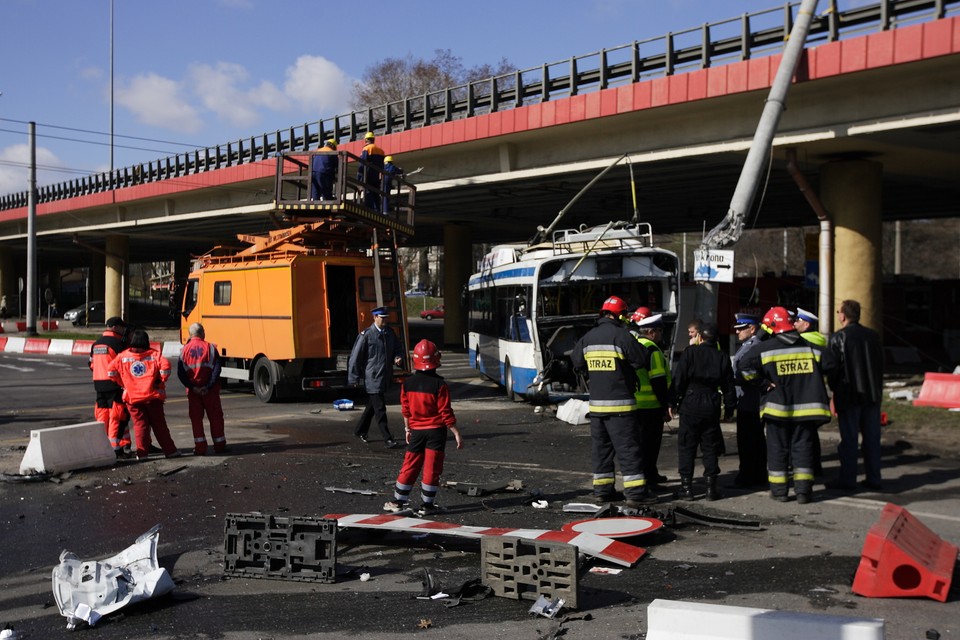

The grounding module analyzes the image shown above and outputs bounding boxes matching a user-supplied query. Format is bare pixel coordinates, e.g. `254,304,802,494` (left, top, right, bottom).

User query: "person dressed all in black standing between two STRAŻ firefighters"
673,324,737,500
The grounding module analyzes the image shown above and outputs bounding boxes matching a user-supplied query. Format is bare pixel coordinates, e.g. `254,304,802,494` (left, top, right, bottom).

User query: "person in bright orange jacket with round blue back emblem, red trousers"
107,329,180,460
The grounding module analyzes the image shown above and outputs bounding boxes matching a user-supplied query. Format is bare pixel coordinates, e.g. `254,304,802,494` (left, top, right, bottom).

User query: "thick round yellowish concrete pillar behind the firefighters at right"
820,160,883,333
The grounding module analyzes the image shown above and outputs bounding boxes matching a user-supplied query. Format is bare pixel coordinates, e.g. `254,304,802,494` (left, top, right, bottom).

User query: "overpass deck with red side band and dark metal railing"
0,0,960,338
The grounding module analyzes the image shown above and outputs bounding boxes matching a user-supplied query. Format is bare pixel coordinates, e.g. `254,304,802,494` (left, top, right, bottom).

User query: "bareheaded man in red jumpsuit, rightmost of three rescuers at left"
177,322,227,456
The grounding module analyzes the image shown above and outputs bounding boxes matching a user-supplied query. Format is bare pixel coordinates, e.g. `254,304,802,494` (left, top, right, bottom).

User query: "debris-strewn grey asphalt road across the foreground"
0,353,960,640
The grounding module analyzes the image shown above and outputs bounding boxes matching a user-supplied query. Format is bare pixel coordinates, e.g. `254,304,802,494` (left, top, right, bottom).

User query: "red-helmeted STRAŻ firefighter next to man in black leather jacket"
741,307,836,504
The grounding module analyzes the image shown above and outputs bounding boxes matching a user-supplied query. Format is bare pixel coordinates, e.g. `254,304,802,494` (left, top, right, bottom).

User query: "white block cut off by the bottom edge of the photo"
647,599,884,640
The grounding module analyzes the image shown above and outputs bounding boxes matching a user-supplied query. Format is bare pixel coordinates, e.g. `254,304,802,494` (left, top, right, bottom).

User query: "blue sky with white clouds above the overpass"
0,0,848,194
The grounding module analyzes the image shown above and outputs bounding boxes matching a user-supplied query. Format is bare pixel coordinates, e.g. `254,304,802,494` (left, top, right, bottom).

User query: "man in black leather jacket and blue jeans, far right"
829,300,883,491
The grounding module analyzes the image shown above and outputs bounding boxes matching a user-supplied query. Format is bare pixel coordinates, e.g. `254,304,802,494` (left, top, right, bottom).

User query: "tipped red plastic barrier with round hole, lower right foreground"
853,503,957,602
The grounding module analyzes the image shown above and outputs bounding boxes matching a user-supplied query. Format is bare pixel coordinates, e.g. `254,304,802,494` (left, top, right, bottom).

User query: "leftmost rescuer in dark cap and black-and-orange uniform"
88,316,130,457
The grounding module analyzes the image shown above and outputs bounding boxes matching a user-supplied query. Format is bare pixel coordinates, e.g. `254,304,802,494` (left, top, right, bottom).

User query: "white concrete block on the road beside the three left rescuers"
20,422,117,474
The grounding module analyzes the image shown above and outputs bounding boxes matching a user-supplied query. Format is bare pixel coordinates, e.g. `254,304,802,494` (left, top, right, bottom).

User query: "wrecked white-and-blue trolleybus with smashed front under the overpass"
467,222,679,403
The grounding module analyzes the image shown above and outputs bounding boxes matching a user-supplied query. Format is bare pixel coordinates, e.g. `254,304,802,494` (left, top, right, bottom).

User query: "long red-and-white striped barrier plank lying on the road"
322,513,646,567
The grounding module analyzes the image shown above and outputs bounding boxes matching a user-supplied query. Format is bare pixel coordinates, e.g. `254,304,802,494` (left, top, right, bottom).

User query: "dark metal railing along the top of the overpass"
0,0,960,210
